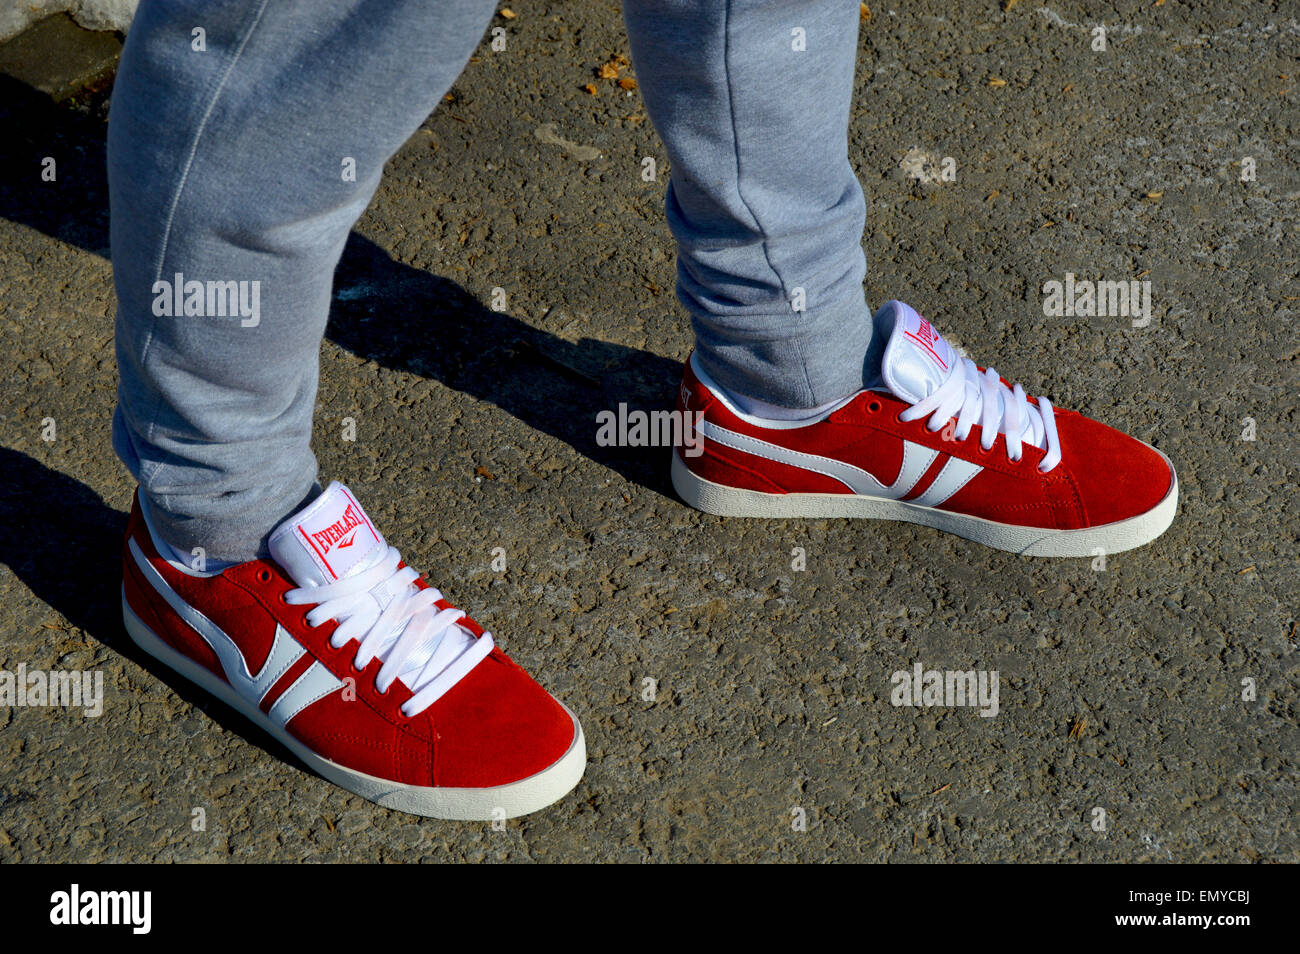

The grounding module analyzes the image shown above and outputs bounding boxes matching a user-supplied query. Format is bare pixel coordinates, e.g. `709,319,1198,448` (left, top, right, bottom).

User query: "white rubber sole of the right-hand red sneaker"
672,450,1178,556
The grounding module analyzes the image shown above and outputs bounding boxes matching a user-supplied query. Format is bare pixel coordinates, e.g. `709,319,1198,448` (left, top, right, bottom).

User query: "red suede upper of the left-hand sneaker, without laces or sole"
124,499,575,788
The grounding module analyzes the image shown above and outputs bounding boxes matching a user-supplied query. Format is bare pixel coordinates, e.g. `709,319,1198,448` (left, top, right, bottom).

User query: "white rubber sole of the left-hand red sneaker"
122,587,586,821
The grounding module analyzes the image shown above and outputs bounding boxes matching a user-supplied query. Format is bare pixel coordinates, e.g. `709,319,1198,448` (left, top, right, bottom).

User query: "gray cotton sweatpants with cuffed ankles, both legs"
108,0,871,561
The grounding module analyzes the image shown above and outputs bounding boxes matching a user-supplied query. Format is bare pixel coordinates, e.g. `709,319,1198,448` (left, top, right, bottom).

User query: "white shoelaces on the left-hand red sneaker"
285,547,494,716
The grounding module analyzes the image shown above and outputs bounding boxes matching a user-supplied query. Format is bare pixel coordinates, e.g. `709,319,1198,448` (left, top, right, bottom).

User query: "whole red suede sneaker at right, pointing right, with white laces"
672,302,1178,556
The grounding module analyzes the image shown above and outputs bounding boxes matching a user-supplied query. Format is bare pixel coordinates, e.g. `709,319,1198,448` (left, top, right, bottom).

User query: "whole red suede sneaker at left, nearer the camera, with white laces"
122,482,586,820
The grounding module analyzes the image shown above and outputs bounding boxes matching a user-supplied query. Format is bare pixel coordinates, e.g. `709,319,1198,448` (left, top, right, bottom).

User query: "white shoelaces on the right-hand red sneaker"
898,357,1061,473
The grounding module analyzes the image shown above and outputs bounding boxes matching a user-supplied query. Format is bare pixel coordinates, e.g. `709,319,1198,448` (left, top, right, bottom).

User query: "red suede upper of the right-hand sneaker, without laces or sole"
677,361,1171,530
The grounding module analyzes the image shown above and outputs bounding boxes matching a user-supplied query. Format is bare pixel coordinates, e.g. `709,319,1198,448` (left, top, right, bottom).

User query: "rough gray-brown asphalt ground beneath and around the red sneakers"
0,0,1300,862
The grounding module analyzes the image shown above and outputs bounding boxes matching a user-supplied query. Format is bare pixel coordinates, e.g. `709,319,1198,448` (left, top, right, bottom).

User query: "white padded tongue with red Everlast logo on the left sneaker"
269,481,387,586
